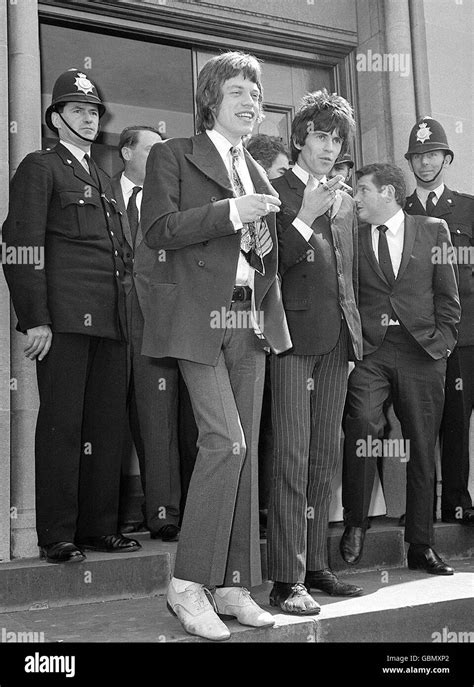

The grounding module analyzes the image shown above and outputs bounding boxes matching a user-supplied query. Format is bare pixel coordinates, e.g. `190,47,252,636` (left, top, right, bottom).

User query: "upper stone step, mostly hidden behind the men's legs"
0,518,474,613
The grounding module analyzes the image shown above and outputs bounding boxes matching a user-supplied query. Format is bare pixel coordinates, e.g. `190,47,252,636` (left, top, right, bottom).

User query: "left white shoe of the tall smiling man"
166,579,230,641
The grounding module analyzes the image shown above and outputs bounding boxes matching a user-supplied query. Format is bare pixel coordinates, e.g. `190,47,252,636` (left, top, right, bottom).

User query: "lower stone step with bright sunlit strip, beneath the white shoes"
0,559,474,654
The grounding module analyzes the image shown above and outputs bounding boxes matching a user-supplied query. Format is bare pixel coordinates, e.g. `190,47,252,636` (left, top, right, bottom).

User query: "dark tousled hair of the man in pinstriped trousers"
291,88,355,162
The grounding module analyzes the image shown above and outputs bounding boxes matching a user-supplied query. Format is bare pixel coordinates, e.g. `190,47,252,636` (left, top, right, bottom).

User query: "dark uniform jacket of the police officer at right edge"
405,186,474,346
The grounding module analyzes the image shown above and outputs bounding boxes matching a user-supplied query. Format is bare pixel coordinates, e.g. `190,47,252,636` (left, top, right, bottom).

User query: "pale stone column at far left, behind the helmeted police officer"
7,0,42,558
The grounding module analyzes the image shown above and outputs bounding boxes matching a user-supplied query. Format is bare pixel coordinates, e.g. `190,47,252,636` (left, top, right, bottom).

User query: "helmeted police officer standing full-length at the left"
3,69,140,563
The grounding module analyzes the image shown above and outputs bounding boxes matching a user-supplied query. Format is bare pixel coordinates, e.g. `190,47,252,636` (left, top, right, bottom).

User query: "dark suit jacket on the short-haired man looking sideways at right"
359,214,461,360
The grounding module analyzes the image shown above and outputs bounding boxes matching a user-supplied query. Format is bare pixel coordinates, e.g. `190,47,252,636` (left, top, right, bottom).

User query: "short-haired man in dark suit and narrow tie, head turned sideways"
340,164,460,575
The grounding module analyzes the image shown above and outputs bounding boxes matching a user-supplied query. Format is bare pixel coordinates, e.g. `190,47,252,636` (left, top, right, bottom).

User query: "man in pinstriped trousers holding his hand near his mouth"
268,90,362,615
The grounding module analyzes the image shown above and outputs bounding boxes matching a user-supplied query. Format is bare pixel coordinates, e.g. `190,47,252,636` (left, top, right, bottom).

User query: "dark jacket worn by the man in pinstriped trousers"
272,170,362,359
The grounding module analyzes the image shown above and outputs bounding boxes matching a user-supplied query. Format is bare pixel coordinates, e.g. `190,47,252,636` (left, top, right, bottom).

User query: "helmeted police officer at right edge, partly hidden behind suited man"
405,117,474,526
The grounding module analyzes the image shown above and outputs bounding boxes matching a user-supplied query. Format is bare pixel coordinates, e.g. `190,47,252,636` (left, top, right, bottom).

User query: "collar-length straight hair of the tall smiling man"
196,51,263,134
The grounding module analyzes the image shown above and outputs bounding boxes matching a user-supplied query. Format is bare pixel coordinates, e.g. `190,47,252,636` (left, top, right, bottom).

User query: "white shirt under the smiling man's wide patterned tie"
206,129,255,289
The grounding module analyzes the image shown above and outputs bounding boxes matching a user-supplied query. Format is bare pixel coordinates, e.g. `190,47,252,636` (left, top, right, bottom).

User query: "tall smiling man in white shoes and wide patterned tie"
142,52,291,640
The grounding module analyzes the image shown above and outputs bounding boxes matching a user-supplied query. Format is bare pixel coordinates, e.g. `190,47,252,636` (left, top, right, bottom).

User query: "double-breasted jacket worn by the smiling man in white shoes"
141,134,291,365
